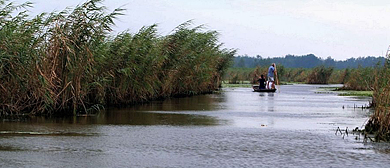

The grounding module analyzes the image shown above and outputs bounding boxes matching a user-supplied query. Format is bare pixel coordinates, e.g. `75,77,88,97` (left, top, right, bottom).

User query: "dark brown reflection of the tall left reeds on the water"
0,94,223,129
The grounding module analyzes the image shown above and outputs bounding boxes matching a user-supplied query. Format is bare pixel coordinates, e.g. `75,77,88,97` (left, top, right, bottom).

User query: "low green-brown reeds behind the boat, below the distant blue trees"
224,65,374,90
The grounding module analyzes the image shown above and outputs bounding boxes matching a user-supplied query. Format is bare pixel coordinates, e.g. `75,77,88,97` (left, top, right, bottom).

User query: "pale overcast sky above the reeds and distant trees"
13,0,390,60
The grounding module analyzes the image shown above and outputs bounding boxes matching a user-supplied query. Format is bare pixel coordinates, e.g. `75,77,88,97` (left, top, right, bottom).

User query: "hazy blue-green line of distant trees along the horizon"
233,54,385,69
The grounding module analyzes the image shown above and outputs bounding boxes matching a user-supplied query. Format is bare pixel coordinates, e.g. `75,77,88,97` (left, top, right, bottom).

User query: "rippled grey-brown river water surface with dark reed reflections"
0,85,390,167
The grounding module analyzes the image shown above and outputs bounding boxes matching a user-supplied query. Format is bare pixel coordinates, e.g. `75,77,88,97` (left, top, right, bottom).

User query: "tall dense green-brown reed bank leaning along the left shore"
0,0,236,117
